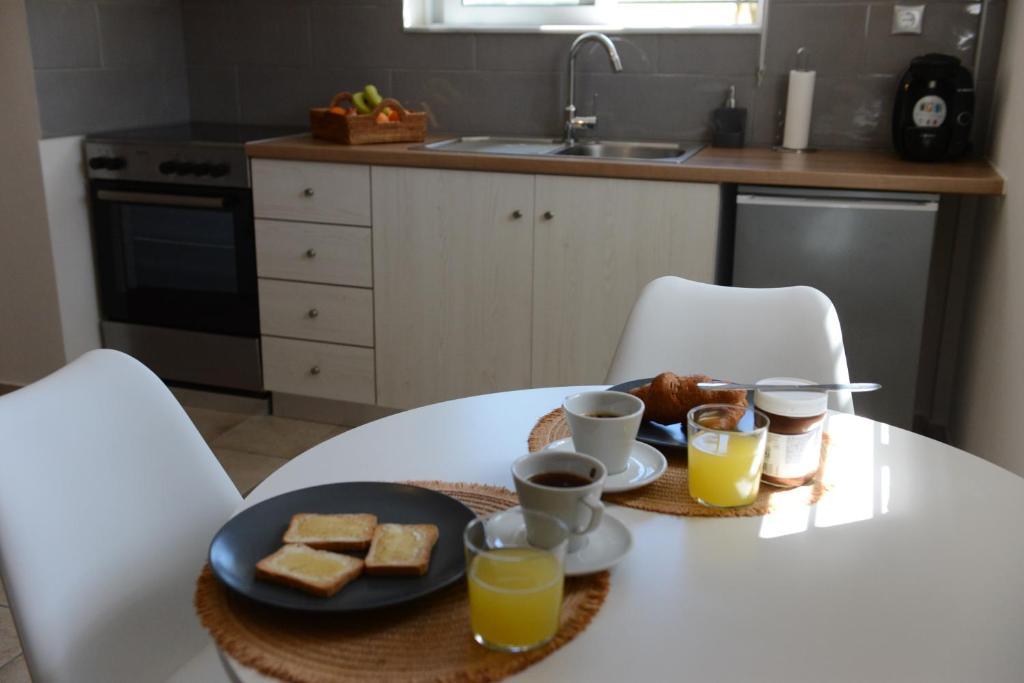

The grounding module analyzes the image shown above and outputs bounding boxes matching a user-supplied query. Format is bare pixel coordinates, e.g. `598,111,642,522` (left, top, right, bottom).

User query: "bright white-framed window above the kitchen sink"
404,0,764,33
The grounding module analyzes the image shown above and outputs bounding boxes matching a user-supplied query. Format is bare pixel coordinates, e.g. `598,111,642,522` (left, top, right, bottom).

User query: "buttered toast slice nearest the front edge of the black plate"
256,543,362,598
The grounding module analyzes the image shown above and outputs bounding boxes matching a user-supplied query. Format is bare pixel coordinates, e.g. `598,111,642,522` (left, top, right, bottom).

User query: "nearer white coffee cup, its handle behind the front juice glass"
512,451,607,553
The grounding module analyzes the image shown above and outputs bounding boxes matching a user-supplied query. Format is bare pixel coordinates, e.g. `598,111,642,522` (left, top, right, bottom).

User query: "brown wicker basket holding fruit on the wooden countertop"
309,92,427,144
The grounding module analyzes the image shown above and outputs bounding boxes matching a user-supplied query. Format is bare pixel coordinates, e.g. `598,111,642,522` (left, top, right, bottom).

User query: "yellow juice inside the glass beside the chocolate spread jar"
687,431,765,508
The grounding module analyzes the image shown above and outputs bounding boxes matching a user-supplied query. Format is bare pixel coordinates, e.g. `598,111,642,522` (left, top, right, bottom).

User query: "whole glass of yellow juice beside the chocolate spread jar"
686,403,768,508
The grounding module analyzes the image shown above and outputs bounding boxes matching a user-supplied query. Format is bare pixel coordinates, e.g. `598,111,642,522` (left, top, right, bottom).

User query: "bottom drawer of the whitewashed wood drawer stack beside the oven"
263,337,377,403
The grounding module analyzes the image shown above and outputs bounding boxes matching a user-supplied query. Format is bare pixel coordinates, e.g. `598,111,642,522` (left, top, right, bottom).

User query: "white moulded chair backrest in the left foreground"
0,350,241,683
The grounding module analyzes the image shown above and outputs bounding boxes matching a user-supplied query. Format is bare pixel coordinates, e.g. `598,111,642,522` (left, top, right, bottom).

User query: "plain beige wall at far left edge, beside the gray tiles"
0,0,65,384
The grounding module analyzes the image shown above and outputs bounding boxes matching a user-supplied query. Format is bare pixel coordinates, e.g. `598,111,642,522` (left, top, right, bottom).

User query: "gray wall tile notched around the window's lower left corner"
312,5,476,70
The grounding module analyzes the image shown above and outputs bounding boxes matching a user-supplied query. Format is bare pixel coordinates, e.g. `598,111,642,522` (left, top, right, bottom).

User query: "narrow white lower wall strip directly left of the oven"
39,135,100,361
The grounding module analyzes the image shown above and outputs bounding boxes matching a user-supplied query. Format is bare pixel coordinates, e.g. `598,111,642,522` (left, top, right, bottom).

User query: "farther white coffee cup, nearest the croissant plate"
562,391,644,474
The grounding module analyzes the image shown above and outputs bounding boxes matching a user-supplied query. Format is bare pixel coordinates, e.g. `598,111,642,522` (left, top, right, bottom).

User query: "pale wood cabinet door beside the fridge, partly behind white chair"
532,176,719,386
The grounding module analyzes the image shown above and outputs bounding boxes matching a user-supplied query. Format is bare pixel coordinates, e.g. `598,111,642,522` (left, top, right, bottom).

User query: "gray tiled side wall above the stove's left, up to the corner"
26,0,188,137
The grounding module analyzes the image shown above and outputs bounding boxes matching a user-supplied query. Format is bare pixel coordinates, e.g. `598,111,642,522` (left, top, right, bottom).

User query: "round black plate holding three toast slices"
210,481,476,612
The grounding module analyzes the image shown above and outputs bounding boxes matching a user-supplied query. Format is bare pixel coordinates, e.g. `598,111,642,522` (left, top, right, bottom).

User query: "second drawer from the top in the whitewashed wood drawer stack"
256,220,374,287
